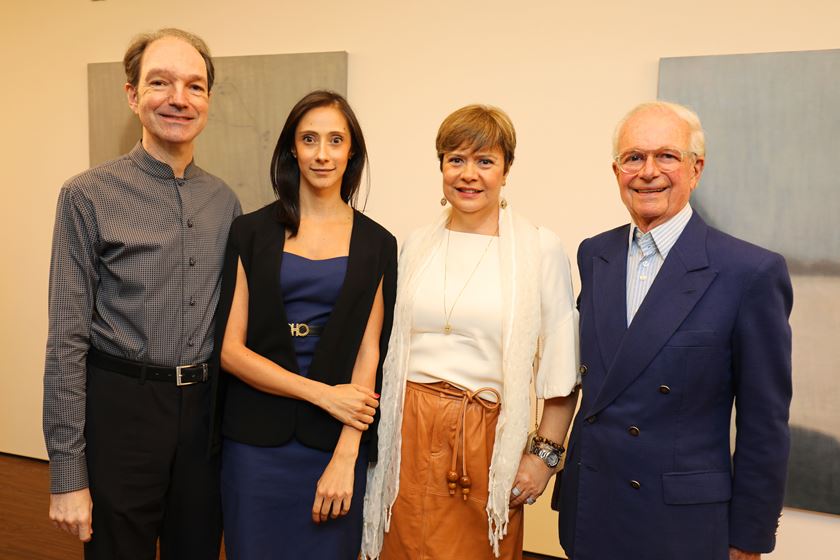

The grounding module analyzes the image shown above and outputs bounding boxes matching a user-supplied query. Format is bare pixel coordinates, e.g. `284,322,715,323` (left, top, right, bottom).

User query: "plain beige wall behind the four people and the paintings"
0,0,840,559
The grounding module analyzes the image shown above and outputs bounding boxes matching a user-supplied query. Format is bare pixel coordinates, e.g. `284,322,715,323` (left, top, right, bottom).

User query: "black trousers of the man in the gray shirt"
85,363,222,560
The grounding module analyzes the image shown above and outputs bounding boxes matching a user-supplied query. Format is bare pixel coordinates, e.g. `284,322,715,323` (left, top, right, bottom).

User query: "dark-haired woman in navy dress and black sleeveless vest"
215,91,396,560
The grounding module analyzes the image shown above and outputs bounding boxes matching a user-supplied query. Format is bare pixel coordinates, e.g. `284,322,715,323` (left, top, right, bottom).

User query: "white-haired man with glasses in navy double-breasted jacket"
554,102,793,560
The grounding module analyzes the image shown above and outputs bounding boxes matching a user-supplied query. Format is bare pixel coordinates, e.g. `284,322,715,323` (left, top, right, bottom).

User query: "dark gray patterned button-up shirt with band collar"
44,142,241,493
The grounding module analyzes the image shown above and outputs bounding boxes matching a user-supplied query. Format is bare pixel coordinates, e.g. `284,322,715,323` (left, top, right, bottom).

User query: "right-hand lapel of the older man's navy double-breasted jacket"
587,213,717,416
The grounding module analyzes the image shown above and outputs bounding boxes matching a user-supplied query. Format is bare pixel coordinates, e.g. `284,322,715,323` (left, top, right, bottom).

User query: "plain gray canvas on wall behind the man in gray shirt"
88,52,347,212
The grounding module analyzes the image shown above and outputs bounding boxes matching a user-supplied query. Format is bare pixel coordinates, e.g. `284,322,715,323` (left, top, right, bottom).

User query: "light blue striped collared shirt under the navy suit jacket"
627,204,693,326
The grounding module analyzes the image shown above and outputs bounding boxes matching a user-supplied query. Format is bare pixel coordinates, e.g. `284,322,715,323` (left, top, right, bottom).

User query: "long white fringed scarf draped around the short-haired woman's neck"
362,206,541,559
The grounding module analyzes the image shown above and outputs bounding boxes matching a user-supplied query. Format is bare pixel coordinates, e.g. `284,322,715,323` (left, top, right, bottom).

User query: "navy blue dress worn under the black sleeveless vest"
222,253,367,560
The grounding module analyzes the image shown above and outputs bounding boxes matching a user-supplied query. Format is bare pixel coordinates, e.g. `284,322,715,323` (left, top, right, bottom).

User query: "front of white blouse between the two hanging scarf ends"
408,231,502,400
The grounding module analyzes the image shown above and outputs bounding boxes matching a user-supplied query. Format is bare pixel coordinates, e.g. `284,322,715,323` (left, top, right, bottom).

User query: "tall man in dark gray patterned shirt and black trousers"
44,29,241,560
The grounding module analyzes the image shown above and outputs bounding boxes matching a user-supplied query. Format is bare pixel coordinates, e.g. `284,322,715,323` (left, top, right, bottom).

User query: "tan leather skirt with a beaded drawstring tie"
381,382,523,560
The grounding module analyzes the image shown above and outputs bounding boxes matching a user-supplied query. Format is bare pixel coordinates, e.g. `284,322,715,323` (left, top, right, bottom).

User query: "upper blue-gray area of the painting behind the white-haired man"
659,50,840,274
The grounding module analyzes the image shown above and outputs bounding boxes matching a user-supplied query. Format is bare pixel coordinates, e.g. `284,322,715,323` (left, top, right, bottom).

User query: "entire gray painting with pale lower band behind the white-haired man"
659,50,840,513
